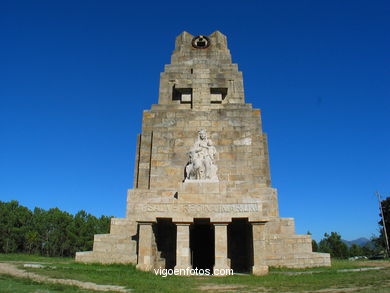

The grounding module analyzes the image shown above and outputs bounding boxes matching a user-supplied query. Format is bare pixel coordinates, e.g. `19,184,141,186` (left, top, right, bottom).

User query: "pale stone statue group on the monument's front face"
185,129,218,181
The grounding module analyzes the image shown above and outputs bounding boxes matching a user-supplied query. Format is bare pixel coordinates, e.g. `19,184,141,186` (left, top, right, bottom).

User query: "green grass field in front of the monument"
0,254,390,293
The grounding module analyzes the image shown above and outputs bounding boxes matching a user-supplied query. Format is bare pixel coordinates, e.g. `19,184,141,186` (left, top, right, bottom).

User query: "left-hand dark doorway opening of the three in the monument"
153,218,176,269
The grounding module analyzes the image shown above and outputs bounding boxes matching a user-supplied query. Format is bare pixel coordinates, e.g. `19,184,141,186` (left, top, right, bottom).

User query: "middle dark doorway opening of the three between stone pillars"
190,219,215,272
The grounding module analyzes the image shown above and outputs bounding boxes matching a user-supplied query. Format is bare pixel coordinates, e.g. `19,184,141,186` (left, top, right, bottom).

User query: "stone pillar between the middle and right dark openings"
214,223,230,269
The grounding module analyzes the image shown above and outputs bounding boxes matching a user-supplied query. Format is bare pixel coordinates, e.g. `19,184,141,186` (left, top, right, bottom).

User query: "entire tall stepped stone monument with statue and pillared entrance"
76,31,330,275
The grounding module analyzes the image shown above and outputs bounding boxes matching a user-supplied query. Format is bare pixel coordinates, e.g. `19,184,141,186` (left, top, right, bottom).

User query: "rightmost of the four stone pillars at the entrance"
251,222,268,275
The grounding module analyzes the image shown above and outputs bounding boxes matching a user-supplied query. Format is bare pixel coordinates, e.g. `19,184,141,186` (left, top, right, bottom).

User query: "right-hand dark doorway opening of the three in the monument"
228,218,253,273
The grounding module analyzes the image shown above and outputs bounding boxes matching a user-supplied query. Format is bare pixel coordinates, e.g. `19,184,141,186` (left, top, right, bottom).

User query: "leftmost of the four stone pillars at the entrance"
137,222,154,271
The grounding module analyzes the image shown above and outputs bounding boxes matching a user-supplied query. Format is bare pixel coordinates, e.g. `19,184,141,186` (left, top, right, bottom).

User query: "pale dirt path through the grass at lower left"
0,263,131,293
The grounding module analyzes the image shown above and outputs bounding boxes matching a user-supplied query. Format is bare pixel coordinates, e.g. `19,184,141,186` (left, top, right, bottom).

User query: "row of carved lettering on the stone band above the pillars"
136,203,260,214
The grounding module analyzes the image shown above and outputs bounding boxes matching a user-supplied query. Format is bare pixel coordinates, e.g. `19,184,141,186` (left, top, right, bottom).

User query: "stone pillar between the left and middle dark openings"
175,223,191,269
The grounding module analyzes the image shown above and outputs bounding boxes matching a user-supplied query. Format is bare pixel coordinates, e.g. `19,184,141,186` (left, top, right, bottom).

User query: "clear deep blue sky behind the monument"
0,0,390,239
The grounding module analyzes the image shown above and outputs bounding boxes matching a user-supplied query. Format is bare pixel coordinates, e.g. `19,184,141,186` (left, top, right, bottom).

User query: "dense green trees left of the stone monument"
0,201,111,256
